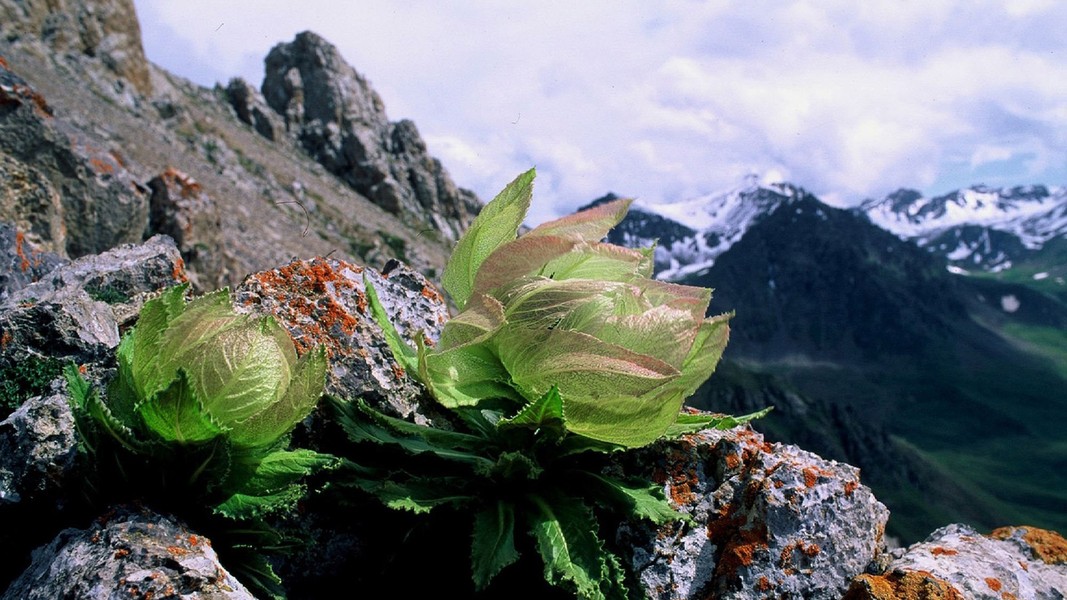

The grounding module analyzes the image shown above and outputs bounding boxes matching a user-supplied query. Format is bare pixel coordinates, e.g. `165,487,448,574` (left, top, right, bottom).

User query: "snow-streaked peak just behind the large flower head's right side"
590,184,805,280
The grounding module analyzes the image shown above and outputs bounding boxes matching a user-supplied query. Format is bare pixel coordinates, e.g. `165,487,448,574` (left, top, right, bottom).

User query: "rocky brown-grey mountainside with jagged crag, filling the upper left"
0,0,480,290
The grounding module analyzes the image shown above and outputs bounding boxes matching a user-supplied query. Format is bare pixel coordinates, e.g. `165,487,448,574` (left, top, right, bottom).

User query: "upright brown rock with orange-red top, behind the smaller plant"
148,168,232,291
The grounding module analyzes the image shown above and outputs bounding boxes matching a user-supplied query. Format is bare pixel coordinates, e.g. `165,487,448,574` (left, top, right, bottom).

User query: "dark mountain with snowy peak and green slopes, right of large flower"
609,185,1067,540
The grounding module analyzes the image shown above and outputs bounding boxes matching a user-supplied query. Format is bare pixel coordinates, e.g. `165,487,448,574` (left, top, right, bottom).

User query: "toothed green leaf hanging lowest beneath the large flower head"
529,494,607,600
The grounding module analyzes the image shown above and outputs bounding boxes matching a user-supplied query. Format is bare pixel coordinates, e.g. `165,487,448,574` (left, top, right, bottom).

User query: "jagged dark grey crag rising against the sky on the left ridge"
262,32,479,239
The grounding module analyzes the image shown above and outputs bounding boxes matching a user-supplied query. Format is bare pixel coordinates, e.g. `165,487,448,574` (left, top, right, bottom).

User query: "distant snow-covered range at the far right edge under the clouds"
857,186,1067,271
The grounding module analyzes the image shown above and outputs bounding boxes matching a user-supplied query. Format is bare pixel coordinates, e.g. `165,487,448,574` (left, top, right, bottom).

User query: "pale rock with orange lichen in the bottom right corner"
845,524,1067,600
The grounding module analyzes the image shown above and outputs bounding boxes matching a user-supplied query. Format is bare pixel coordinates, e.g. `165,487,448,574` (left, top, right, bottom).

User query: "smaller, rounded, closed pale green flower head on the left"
109,286,327,447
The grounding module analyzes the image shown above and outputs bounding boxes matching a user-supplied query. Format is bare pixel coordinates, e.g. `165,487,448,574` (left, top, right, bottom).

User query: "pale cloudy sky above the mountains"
134,0,1067,222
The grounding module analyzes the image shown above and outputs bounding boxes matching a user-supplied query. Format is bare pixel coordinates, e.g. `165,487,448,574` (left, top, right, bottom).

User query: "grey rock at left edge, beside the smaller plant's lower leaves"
0,393,78,506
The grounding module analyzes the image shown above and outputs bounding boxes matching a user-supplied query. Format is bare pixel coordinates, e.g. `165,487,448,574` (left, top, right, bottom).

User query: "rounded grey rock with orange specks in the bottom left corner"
0,503,254,600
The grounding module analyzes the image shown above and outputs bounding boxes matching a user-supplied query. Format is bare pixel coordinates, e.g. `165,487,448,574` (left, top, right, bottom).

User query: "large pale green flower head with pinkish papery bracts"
418,170,729,447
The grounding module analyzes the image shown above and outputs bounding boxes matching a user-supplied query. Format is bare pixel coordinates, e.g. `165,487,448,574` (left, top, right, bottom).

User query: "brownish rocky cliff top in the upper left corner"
0,0,152,95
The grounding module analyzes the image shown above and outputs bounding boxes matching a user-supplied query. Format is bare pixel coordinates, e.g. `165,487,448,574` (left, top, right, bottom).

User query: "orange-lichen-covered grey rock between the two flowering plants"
234,254,448,423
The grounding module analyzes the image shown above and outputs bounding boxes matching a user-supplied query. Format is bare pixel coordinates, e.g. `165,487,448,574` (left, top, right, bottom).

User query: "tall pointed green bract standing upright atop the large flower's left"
441,169,537,310
